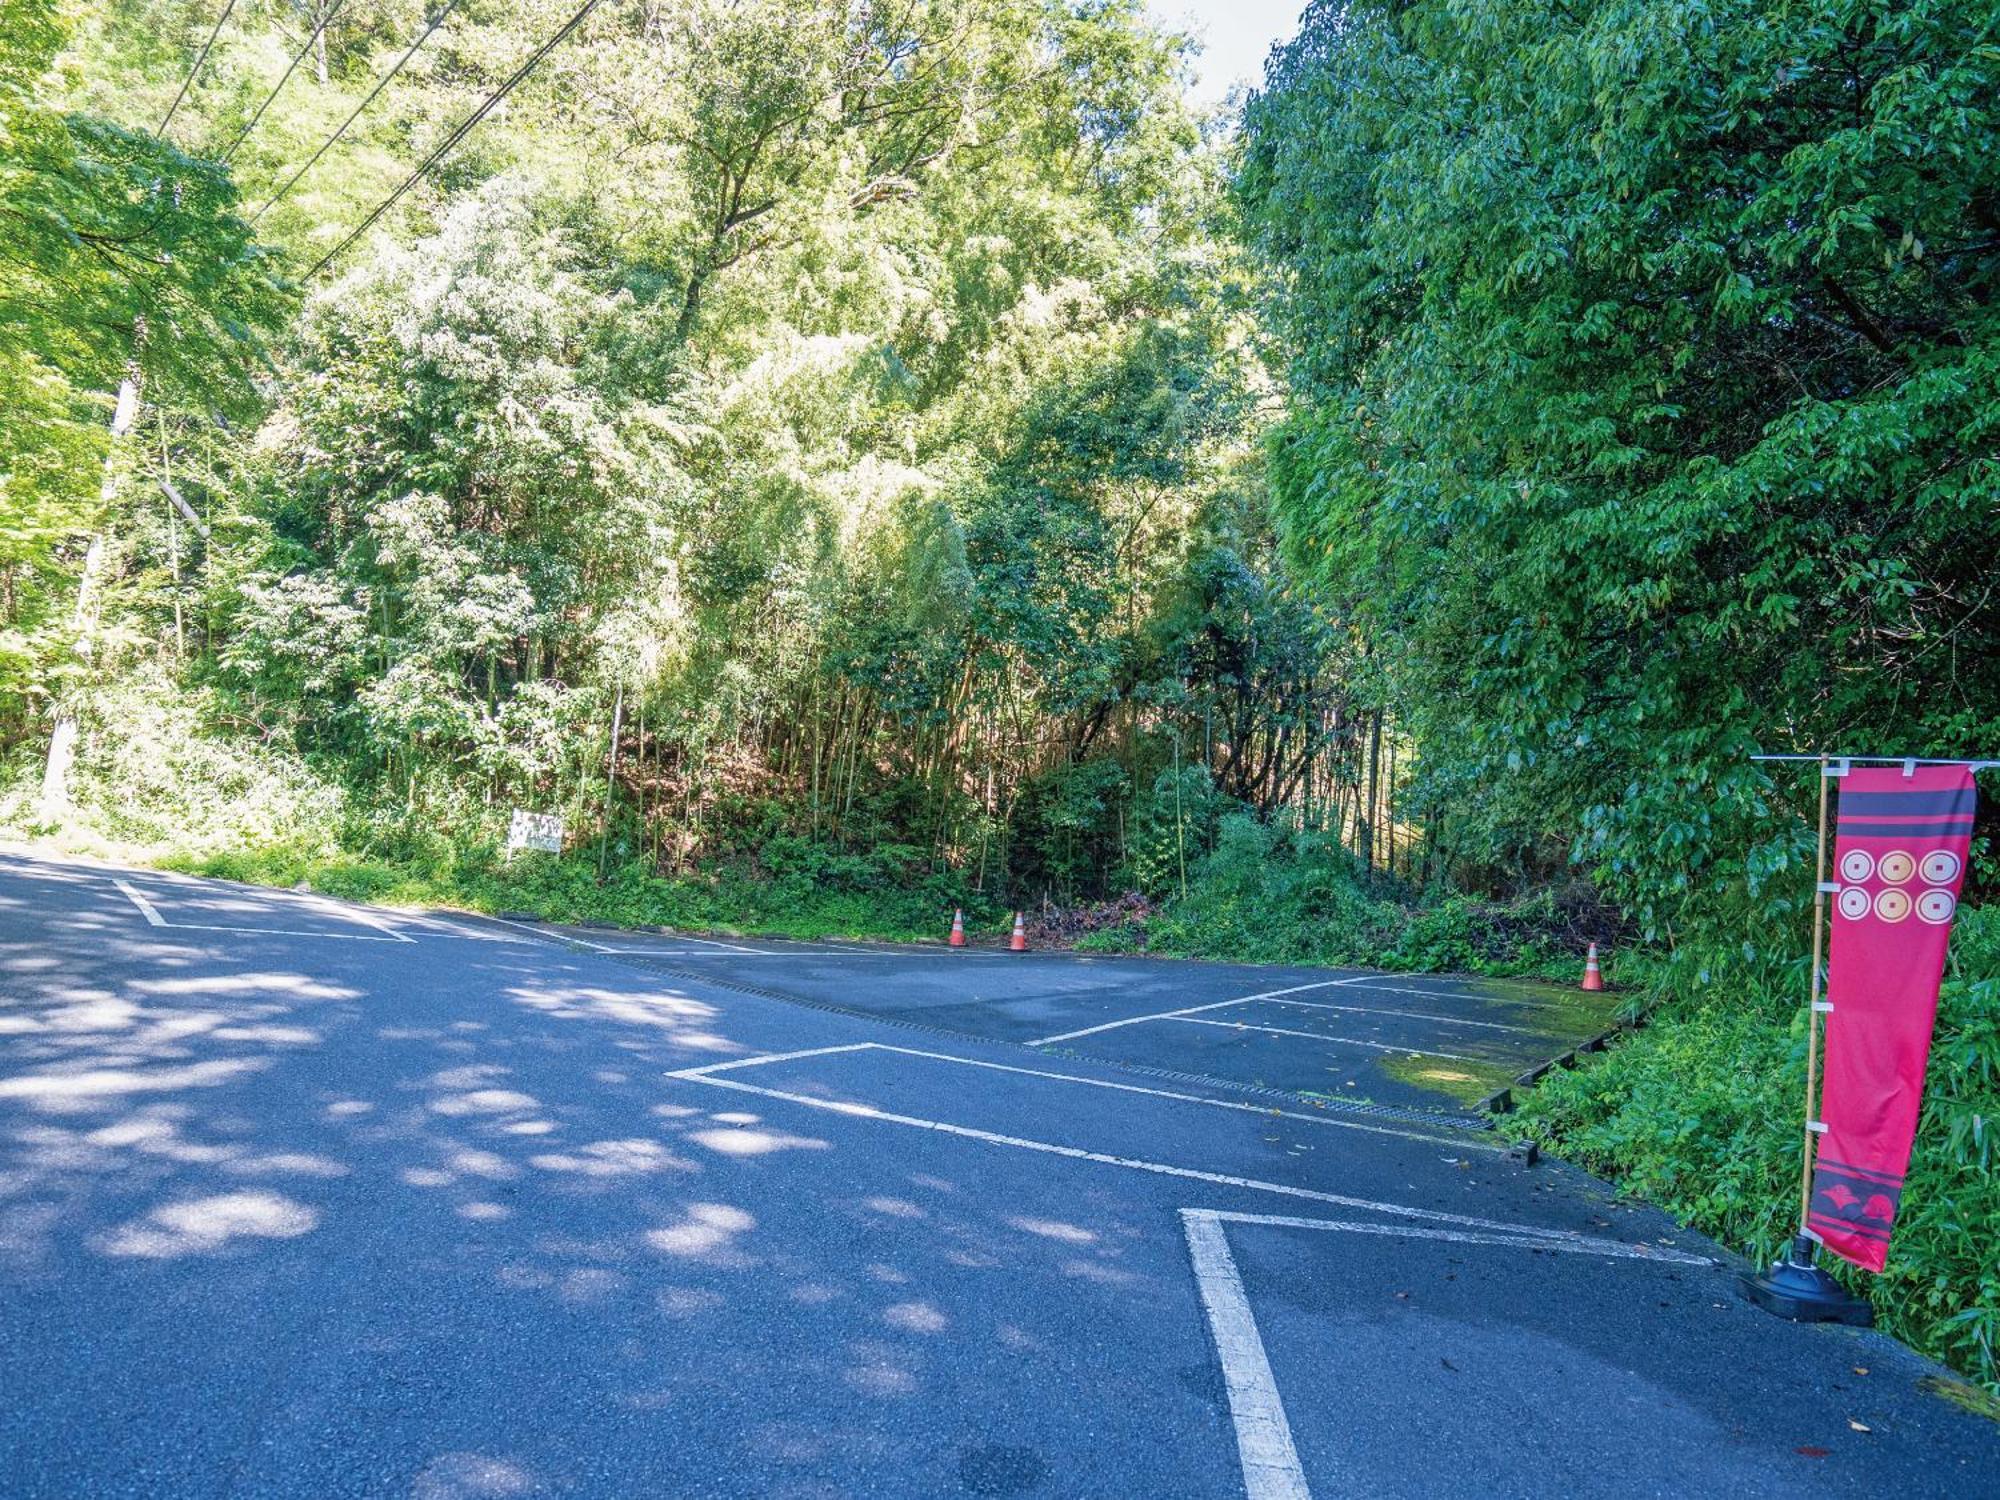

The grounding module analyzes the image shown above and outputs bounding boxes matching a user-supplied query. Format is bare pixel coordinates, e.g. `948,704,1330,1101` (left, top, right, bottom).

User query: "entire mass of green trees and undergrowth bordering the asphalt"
0,0,2000,1388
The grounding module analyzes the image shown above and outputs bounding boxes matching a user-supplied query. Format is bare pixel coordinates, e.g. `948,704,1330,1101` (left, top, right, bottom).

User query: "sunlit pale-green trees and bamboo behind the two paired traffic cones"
8,0,1414,900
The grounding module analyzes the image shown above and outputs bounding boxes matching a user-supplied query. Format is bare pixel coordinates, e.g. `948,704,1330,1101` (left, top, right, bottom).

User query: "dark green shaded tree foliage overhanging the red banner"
1242,0,2000,944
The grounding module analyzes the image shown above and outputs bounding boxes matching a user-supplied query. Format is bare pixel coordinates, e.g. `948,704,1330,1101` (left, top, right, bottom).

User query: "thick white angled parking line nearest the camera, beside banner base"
1180,1208,1712,1500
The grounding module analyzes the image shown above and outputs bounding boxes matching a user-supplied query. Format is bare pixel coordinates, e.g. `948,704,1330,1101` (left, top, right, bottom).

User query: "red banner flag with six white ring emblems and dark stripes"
1806,766,1976,1270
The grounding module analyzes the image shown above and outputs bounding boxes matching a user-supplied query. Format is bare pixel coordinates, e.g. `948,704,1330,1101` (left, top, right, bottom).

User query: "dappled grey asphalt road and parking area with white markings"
0,856,2000,1500
